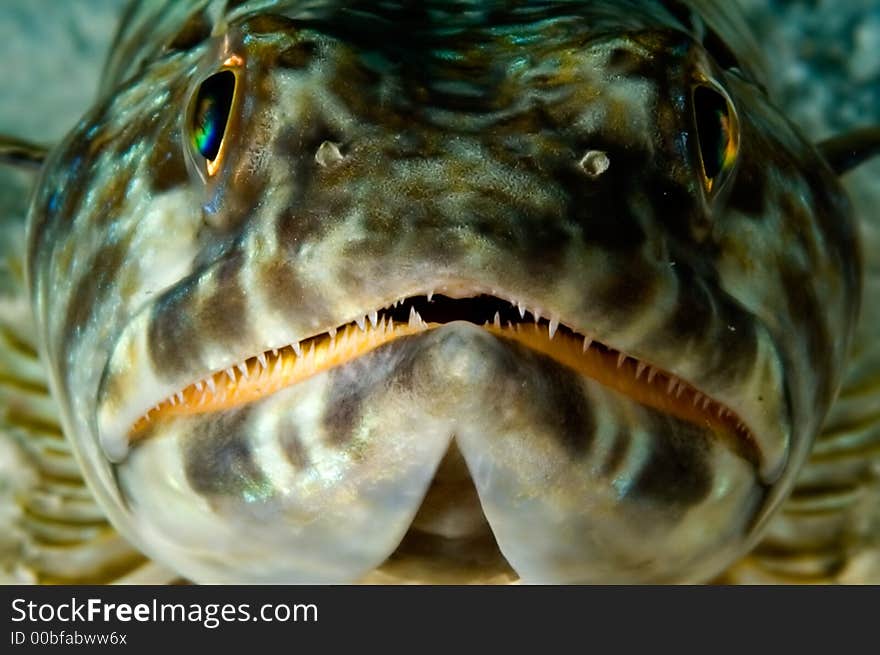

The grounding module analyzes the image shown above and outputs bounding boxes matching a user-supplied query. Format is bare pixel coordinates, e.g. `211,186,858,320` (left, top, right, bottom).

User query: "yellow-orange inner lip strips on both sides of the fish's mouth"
129,316,753,462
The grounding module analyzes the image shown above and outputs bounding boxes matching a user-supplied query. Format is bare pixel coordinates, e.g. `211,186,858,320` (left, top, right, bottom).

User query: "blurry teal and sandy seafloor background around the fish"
0,0,880,581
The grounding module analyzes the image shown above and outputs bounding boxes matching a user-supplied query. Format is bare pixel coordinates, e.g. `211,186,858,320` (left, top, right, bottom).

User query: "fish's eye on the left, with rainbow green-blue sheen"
190,70,235,175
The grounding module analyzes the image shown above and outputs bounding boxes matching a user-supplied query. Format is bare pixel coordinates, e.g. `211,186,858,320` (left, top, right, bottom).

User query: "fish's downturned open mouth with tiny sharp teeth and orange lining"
128,293,760,465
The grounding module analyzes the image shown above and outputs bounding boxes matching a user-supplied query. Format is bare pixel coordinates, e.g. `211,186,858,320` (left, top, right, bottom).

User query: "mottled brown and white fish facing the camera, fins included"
0,0,880,584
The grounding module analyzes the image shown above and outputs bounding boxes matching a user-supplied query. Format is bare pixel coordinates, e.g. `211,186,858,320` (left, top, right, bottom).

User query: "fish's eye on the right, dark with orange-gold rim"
693,85,739,193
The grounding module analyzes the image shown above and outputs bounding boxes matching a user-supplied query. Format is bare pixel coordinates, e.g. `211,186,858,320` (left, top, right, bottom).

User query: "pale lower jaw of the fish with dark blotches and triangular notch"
116,321,766,583
